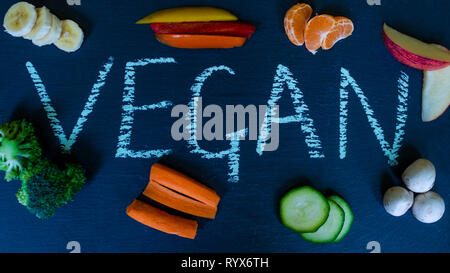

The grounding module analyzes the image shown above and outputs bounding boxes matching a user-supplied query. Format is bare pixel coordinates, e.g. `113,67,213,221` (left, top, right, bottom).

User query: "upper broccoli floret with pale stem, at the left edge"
0,120,42,181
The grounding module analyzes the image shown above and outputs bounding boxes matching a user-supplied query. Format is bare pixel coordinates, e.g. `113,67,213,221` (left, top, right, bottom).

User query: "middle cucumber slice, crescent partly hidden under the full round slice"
301,200,345,244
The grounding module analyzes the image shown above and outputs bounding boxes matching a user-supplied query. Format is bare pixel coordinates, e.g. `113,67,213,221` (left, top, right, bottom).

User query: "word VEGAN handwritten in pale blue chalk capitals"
26,57,409,182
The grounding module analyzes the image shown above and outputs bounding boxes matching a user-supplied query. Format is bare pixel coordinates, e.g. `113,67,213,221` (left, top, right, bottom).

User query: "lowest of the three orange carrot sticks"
127,200,198,239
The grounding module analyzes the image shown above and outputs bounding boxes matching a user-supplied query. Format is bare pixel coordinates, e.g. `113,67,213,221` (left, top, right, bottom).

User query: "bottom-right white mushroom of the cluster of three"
412,191,445,224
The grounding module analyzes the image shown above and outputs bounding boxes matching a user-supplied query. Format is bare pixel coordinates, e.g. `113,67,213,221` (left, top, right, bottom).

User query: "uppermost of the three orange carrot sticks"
146,163,220,207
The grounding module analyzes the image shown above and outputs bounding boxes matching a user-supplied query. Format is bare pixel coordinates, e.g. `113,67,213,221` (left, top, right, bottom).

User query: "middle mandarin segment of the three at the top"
305,14,336,54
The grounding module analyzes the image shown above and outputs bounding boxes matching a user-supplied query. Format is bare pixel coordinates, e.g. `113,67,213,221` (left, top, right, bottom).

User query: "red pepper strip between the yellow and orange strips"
150,21,256,38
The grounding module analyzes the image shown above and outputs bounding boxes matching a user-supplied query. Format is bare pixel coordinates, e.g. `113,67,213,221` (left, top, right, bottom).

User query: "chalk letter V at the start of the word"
26,57,114,153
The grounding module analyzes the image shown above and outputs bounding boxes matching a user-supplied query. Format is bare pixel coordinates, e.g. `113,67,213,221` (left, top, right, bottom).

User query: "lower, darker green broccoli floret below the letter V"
16,160,86,218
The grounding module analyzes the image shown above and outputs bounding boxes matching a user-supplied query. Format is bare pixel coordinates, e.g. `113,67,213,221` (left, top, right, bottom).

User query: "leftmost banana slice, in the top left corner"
3,2,37,37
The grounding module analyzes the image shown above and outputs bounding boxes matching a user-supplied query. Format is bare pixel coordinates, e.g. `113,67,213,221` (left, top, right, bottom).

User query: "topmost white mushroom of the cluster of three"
402,158,436,193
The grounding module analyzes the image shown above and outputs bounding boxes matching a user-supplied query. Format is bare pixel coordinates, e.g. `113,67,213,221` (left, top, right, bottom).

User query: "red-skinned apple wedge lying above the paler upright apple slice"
383,24,450,70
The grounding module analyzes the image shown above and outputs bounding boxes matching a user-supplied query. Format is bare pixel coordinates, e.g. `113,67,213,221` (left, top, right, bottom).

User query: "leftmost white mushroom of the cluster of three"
383,187,414,216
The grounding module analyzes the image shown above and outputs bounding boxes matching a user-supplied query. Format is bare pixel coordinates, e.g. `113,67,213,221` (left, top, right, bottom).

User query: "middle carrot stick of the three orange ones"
144,181,217,219
